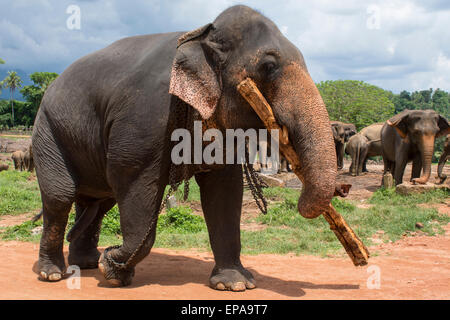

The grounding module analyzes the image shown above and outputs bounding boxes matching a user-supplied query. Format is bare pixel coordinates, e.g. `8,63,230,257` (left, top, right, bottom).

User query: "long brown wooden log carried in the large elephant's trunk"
237,78,370,266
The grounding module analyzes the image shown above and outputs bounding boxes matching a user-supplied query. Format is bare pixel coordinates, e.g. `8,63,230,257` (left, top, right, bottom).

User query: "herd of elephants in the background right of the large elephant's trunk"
331,110,450,184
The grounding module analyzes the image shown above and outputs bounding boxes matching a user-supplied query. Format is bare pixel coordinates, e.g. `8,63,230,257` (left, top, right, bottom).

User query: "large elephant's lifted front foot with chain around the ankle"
98,250,134,287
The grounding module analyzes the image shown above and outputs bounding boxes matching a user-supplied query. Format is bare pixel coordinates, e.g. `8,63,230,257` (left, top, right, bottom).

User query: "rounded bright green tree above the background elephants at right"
317,80,395,130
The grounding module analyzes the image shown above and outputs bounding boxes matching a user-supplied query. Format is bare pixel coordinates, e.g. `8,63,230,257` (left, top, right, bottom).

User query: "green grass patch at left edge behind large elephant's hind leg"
0,170,42,216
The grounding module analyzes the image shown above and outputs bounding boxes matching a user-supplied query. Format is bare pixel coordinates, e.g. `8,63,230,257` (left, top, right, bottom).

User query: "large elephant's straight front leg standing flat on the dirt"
195,165,256,291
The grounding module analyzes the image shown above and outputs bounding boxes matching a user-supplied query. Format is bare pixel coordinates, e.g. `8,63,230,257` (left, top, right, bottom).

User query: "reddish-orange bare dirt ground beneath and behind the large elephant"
0,133,450,300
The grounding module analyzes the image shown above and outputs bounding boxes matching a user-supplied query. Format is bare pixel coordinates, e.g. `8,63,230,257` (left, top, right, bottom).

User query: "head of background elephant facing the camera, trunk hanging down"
387,110,450,184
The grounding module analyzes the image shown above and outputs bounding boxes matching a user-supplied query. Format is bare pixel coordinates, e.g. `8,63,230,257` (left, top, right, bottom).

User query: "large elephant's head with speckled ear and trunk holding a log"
169,6,336,218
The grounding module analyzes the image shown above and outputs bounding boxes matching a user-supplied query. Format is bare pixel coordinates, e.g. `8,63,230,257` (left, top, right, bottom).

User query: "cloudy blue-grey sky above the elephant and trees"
0,0,450,97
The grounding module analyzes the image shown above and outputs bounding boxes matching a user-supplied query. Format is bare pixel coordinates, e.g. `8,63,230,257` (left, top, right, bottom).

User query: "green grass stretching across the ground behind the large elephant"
0,171,450,256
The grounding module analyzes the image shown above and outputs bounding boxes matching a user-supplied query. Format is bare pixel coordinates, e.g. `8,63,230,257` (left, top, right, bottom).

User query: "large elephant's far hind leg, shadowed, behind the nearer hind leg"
68,199,116,269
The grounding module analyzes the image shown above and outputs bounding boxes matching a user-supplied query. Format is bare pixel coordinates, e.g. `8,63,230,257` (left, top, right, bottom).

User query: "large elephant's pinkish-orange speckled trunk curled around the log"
271,64,337,218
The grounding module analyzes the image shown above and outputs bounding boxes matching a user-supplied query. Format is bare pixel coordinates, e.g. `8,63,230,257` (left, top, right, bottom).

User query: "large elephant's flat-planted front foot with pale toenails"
209,266,256,291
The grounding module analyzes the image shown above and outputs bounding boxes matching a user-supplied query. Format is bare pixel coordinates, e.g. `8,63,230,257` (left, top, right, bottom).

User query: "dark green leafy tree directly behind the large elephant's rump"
20,72,58,117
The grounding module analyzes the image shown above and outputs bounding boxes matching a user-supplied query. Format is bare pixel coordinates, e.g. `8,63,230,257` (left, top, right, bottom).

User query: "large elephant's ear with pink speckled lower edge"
169,23,221,119
